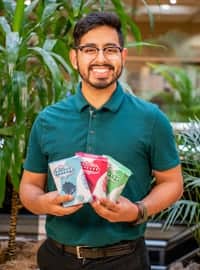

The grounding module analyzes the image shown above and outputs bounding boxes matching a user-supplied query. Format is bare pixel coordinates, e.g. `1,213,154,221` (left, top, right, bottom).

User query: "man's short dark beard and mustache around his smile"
77,64,123,89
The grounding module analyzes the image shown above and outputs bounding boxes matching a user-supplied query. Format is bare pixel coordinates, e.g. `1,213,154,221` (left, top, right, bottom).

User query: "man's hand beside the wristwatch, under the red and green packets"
91,196,138,222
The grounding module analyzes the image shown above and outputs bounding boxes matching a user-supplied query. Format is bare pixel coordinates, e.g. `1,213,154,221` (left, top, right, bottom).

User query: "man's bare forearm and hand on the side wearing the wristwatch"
92,165,183,222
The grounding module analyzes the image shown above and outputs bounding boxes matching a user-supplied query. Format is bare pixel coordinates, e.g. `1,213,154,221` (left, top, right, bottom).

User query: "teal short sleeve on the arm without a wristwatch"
24,115,48,173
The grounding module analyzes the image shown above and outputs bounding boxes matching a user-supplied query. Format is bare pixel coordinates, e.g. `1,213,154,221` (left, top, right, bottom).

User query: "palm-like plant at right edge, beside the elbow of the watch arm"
164,118,200,245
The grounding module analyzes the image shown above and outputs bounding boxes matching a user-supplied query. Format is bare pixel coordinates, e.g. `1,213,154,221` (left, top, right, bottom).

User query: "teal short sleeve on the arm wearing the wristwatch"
150,109,180,171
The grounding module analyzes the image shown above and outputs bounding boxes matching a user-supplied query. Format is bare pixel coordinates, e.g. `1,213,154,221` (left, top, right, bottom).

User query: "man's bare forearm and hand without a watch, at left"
19,170,82,216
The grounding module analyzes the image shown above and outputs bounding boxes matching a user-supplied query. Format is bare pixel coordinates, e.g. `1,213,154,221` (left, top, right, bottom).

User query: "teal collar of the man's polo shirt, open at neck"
75,82,125,112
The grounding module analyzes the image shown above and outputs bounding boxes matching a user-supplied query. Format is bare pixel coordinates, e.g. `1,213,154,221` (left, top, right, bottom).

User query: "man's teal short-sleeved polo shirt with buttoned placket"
24,83,179,246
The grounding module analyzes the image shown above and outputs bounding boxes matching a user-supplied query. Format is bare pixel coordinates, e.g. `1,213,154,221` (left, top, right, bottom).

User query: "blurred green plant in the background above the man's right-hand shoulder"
148,64,200,122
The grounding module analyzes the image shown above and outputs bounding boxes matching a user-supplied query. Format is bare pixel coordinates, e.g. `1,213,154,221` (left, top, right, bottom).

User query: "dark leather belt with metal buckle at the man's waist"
49,238,138,259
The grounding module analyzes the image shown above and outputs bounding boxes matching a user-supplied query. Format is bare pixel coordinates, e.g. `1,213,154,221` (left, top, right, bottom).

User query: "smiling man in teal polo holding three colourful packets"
20,12,183,270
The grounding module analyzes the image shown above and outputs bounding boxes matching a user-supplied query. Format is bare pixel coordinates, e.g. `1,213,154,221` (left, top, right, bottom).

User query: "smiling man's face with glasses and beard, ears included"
72,26,126,89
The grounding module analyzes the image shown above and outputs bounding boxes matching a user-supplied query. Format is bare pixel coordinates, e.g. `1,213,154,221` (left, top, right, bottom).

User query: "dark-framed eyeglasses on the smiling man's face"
75,45,122,59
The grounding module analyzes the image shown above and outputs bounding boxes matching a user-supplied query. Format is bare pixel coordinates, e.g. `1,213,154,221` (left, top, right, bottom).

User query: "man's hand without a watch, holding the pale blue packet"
38,191,83,216
